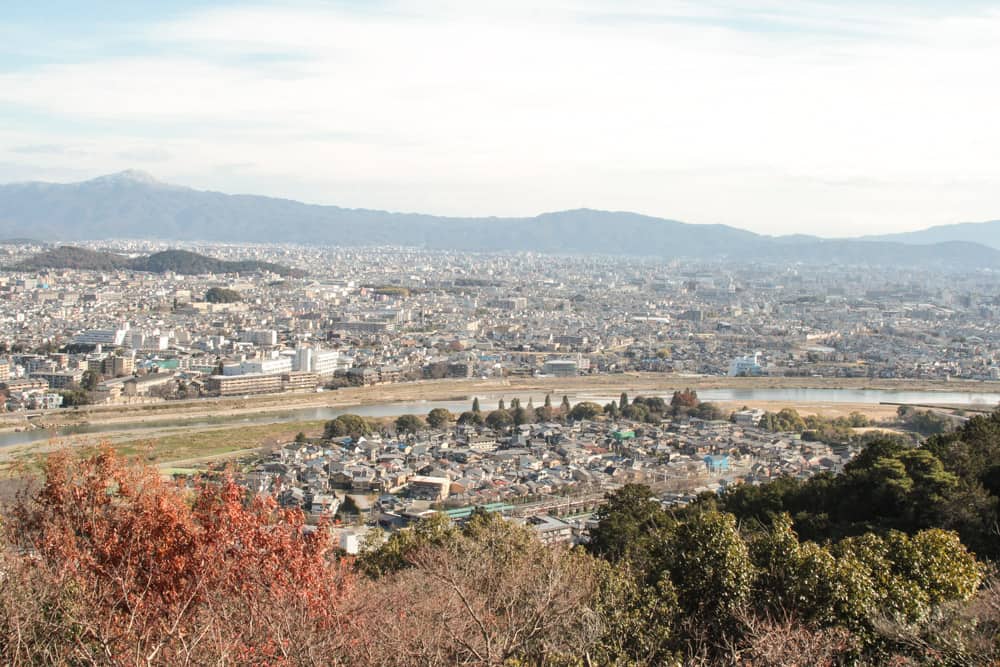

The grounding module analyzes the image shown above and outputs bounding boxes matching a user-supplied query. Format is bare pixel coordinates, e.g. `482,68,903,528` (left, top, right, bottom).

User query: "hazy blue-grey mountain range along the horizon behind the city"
0,171,1000,268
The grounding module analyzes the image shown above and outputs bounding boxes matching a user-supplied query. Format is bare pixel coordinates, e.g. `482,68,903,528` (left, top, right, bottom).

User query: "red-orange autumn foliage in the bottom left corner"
0,448,351,665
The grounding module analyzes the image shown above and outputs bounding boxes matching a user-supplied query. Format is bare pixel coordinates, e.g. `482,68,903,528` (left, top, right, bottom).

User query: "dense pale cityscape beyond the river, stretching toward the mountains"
0,242,1000,410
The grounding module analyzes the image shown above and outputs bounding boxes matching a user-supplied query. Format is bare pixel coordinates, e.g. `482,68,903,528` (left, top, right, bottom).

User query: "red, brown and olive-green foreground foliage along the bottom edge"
0,440,1000,667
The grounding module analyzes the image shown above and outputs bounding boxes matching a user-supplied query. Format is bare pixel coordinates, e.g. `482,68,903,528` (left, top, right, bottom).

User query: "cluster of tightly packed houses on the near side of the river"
236,418,856,552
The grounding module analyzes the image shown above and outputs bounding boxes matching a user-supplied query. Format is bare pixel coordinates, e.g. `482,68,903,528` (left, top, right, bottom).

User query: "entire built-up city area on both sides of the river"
0,241,1000,550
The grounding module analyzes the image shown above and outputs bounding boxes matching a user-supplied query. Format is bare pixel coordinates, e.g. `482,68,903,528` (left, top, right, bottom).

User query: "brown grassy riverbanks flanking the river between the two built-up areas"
0,374,988,475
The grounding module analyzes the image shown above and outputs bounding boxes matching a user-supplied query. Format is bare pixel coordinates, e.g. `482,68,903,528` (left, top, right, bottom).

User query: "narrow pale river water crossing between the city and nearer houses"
0,389,1000,447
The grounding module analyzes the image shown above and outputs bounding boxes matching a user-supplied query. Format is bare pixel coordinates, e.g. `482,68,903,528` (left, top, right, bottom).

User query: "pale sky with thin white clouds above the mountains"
0,0,1000,236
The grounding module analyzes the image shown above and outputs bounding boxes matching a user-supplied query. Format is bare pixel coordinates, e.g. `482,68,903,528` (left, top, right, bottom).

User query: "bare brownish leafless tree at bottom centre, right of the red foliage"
354,513,599,667
